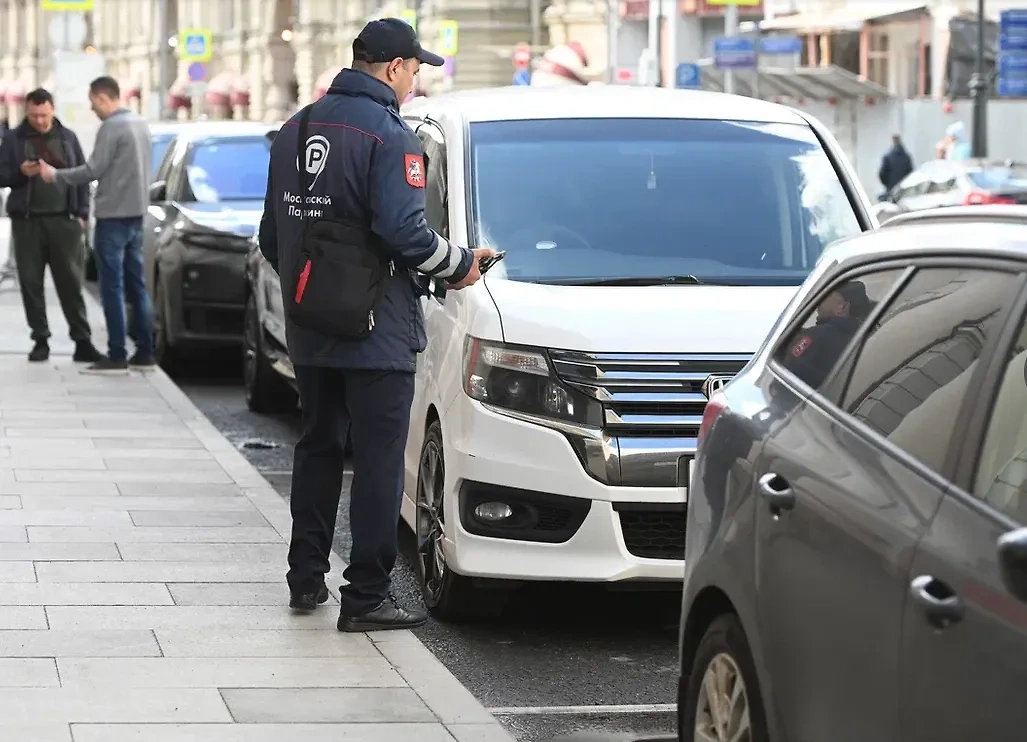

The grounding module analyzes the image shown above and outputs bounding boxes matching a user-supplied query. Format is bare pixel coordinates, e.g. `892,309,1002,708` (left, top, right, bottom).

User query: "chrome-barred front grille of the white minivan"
549,350,751,487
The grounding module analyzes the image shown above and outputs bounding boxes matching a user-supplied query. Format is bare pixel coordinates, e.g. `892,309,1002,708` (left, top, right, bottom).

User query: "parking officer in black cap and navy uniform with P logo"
259,18,494,631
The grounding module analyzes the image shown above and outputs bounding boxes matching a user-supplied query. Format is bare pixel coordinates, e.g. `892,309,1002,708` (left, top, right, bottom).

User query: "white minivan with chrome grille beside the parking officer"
392,85,876,619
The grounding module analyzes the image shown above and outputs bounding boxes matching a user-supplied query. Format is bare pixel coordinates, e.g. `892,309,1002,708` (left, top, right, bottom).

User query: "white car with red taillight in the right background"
874,159,1027,224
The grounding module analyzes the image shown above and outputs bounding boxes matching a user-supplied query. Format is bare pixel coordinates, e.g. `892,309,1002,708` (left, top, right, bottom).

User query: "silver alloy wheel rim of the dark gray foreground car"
692,653,753,742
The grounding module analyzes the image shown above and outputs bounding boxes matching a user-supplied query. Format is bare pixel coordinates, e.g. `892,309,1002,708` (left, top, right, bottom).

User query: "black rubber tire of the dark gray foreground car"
679,614,769,742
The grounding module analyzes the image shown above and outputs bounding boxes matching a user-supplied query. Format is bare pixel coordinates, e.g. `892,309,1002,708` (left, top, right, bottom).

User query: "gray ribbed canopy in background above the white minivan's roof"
698,60,890,101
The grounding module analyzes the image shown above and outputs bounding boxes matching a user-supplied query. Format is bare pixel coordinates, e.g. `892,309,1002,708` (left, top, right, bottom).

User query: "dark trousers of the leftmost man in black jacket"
10,215,90,342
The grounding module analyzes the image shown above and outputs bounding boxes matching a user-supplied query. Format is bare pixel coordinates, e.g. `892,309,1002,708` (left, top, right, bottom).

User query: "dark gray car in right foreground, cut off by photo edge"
679,207,1027,742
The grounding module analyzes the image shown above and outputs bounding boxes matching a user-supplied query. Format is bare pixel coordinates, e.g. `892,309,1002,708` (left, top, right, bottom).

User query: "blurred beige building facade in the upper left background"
0,0,548,122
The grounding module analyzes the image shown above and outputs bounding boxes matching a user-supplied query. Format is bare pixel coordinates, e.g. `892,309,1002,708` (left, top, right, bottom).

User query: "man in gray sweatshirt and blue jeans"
39,77,154,373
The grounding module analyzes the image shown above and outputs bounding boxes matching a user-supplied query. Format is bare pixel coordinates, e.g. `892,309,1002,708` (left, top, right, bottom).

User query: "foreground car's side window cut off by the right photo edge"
972,314,1027,525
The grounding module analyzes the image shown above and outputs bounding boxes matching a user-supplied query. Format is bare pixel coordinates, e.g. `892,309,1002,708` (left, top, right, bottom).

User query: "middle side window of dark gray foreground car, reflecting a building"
842,268,1017,473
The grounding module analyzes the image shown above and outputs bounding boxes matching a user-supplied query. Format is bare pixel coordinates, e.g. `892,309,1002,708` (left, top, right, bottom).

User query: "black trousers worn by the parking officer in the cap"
286,366,414,616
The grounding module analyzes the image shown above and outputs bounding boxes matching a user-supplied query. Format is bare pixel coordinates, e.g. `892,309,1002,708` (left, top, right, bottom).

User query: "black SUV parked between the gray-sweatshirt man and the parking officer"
144,122,279,369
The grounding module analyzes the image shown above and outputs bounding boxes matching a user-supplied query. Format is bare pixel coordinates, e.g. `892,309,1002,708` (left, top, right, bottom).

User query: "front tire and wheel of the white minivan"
414,420,508,622
